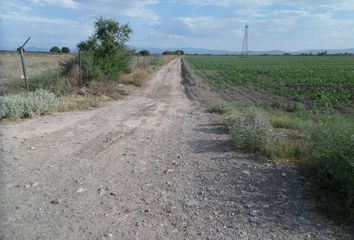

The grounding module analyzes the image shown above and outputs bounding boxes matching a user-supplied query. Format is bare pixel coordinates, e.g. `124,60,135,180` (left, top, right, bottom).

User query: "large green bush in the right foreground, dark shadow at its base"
305,116,354,216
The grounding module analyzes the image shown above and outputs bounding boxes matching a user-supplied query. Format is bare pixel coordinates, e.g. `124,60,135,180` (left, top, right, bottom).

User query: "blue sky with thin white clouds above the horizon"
0,0,354,51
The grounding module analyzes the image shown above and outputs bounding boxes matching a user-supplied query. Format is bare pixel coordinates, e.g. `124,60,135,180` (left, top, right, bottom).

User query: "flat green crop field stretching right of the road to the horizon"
186,56,354,109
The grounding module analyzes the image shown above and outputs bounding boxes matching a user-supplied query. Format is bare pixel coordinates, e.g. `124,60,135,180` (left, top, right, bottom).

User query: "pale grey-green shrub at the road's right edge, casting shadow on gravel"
226,112,281,153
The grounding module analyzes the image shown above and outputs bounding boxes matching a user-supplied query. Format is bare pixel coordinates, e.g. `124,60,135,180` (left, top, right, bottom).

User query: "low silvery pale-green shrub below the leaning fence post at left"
0,89,57,119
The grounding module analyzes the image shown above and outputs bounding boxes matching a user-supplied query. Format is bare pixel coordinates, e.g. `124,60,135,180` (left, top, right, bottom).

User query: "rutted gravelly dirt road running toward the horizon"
0,60,350,240
